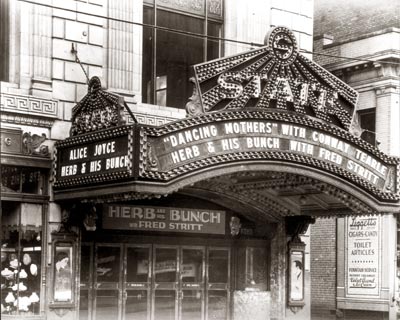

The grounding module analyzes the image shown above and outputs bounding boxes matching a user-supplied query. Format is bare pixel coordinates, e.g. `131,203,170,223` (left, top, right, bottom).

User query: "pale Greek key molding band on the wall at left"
0,93,58,119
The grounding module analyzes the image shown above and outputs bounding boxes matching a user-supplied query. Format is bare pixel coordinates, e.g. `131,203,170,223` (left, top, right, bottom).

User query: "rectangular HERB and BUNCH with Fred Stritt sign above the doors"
103,205,225,234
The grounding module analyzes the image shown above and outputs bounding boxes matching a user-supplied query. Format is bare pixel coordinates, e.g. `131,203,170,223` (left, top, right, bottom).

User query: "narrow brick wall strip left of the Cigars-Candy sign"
310,218,336,320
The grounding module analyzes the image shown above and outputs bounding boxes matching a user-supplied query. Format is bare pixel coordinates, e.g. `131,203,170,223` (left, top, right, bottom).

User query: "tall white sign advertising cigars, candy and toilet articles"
346,216,380,296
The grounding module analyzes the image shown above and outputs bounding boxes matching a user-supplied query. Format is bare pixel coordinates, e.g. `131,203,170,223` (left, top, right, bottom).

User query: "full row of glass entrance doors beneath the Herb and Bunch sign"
80,243,230,320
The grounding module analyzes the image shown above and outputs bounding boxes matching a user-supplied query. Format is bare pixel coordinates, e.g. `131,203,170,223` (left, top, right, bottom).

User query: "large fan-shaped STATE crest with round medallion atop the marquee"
187,27,358,134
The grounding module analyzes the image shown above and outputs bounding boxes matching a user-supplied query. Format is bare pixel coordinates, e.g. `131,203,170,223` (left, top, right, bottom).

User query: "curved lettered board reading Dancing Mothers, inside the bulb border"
145,119,395,191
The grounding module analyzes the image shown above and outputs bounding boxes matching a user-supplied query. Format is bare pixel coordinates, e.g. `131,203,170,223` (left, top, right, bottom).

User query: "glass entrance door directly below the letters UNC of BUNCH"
178,247,205,320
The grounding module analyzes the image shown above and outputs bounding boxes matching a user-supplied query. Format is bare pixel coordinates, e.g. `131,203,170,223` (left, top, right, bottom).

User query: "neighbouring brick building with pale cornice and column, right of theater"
311,0,400,319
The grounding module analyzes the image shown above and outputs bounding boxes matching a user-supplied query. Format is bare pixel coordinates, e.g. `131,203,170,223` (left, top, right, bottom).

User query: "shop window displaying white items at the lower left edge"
1,202,42,315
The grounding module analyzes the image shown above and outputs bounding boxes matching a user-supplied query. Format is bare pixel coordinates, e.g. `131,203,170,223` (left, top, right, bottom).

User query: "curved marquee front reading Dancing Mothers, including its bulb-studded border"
141,111,397,197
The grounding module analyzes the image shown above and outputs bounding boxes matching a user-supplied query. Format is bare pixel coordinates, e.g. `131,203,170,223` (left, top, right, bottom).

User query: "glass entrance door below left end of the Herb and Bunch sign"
93,244,123,320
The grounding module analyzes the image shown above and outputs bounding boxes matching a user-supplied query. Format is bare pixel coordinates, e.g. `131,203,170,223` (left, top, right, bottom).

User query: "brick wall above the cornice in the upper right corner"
314,0,400,42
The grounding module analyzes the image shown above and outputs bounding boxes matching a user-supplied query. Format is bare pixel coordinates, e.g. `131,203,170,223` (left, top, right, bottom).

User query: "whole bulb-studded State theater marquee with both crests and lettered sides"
54,27,400,212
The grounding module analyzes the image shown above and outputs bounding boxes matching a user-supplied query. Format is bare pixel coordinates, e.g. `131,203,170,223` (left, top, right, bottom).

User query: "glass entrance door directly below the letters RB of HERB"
123,245,152,320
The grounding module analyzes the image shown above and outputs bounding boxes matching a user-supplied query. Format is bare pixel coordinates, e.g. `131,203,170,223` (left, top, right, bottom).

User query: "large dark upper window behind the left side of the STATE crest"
142,0,223,108
